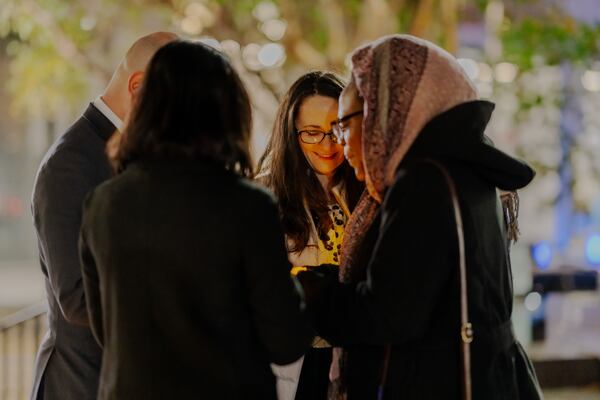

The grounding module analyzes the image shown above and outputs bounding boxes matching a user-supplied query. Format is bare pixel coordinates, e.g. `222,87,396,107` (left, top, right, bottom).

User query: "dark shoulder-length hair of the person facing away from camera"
111,40,252,177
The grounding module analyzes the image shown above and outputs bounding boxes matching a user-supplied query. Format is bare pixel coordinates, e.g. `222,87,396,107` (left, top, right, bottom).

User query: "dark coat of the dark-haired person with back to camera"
80,162,312,400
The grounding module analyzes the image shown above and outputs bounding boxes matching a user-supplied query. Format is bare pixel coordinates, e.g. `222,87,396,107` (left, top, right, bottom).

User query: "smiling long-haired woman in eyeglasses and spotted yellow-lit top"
258,71,363,400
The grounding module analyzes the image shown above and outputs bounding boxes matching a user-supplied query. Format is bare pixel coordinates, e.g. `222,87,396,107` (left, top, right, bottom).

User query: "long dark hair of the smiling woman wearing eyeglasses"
258,71,363,251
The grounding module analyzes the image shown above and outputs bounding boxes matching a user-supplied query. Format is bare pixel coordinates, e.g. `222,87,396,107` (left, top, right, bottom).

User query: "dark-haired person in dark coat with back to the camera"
80,41,312,400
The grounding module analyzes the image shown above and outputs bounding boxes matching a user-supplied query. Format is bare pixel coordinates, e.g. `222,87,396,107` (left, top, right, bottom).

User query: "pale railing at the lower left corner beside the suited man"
0,302,47,400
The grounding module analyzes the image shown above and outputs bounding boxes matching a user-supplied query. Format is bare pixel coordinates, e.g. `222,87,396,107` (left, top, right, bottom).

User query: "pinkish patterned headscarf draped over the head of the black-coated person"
330,35,477,399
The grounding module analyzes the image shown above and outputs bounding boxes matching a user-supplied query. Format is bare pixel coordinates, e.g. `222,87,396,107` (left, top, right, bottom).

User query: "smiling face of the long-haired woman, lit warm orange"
296,95,344,178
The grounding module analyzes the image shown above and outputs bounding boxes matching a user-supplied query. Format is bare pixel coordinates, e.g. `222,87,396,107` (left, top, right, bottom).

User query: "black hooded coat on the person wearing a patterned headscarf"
303,101,541,400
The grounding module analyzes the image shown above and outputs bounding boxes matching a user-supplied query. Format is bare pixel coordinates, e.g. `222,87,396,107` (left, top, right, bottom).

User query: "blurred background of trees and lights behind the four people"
0,0,600,400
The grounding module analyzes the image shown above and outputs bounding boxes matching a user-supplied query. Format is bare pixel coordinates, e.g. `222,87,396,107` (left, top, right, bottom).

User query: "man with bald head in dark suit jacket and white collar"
31,32,177,400
